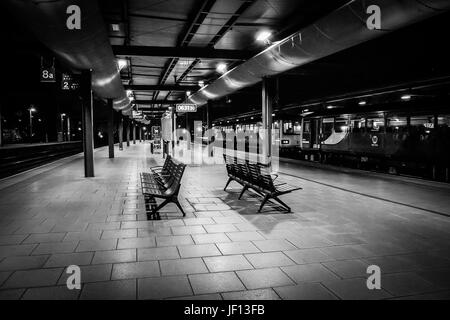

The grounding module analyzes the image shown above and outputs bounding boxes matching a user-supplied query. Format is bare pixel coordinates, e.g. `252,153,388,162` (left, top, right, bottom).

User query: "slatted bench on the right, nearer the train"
224,155,302,212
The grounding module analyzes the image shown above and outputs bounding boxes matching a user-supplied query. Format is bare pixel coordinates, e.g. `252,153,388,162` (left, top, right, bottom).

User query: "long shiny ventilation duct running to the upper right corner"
188,0,450,105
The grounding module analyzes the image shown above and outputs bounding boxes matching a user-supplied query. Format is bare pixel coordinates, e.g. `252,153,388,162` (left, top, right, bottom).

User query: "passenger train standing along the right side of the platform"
211,108,450,182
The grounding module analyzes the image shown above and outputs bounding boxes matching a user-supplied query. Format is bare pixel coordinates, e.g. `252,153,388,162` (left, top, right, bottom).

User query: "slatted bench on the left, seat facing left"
141,157,186,218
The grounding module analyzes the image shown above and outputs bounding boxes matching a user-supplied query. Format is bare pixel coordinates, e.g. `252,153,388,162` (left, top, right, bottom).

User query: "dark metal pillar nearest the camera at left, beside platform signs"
81,70,94,178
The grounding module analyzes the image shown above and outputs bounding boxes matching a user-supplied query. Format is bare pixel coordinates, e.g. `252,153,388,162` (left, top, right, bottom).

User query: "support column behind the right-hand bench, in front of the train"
262,78,274,163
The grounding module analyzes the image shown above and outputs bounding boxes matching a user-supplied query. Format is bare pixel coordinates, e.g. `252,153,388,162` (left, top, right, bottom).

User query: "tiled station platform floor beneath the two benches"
0,144,450,299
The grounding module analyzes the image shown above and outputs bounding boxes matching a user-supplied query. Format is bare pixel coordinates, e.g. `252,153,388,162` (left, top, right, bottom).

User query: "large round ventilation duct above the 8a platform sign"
2,0,131,110
